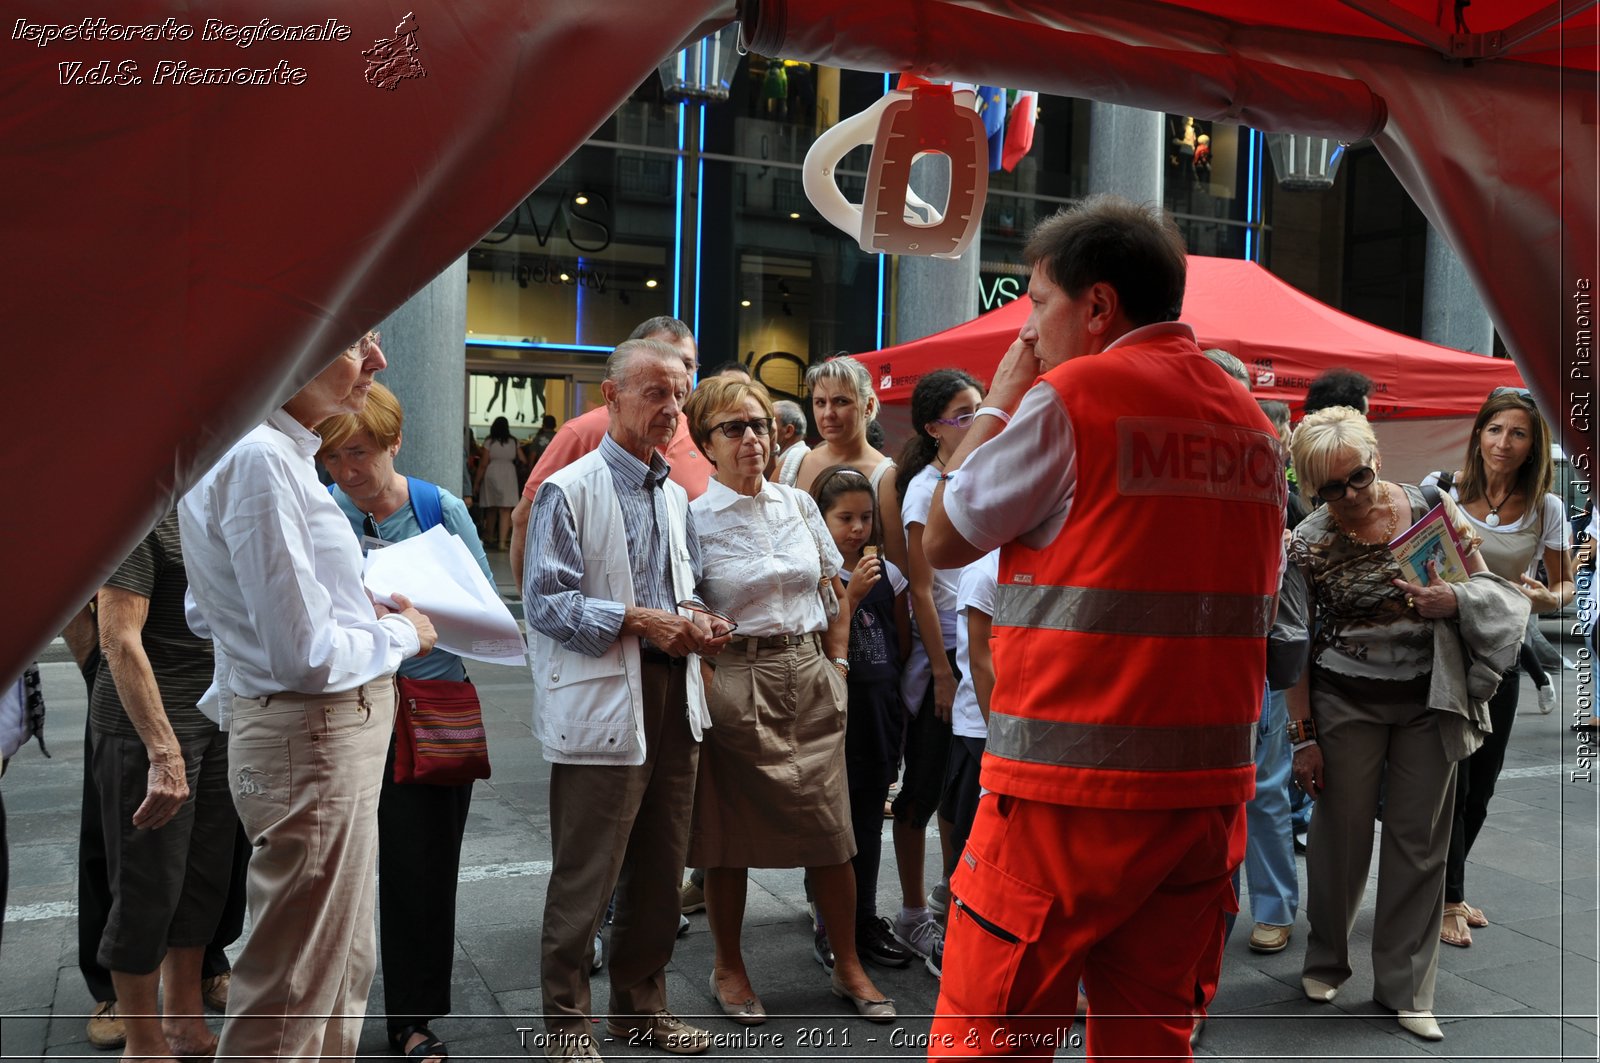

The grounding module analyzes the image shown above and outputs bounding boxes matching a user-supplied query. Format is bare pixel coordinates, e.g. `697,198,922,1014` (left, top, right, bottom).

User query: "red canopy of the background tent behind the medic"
861,255,1522,419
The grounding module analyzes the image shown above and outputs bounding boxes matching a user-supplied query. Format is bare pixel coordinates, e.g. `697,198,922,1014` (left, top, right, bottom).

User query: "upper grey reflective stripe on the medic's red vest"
994,583,1272,639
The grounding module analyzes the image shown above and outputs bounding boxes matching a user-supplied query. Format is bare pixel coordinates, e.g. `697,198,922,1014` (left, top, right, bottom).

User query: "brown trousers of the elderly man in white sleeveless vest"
539,656,699,1034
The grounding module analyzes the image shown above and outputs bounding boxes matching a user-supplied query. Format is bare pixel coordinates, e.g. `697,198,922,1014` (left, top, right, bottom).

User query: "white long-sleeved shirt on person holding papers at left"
178,410,421,727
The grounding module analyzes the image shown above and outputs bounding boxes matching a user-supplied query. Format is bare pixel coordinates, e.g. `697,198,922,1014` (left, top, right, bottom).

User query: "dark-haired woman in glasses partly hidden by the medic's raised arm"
893,370,984,973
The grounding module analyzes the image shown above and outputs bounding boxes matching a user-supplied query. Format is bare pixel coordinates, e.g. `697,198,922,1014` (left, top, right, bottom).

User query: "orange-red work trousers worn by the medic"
928,794,1245,1060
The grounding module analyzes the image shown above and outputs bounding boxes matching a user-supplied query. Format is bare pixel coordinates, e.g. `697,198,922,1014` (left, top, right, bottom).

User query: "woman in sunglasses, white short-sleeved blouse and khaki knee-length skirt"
685,376,896,1025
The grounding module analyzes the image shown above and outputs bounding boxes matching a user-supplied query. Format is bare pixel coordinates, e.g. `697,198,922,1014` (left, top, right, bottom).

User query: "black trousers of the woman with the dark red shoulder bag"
378,736,472,1034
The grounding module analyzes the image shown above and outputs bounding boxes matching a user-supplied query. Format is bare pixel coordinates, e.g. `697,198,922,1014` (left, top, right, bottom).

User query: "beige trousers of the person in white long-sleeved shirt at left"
218,679,395,1060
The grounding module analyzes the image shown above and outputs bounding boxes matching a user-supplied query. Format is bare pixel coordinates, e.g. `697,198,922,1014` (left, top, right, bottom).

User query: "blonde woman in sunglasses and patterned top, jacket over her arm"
1288,407,1526,1041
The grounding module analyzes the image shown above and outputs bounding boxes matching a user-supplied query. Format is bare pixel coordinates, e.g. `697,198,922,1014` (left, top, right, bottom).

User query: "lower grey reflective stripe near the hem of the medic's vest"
984,712,1256,772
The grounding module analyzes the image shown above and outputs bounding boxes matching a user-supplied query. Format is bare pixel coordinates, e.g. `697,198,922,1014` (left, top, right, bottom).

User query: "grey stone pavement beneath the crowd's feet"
0,592,1600,1061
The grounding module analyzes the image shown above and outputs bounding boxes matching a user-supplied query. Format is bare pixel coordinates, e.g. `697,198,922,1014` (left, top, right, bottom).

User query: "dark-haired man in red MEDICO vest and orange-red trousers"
923,195,1283,1058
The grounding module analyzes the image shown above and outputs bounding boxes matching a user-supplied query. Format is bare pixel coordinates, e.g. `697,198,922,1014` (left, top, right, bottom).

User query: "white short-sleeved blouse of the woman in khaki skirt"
690,479,843,639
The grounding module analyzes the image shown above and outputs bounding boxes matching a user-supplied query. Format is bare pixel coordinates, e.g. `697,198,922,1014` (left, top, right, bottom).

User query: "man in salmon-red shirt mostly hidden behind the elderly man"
510,314,715,586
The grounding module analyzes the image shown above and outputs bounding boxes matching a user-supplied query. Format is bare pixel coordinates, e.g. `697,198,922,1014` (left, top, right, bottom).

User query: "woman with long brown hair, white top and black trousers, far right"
1422,387,1576,948
